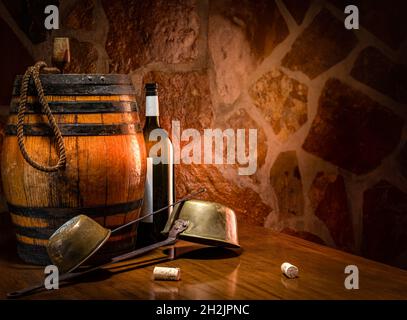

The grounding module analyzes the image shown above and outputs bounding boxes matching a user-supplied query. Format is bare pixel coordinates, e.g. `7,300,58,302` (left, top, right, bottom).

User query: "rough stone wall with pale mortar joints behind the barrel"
0,0,407,268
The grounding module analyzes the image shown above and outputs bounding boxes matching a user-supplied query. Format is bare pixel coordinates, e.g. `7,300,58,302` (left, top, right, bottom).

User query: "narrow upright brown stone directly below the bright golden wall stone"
270,151,304,220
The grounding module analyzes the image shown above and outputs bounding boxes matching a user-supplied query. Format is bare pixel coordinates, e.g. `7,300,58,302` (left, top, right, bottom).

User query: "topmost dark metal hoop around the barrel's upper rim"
13,74,135,96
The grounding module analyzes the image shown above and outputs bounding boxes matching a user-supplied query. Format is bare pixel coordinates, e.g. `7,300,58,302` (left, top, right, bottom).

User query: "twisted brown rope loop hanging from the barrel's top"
17,61,66,172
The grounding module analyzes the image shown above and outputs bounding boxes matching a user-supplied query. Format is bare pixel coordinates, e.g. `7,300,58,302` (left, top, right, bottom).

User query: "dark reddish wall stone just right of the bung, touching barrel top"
64,38,98,73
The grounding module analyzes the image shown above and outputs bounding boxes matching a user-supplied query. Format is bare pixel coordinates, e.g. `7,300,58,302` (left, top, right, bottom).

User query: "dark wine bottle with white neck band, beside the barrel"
137,83,175,247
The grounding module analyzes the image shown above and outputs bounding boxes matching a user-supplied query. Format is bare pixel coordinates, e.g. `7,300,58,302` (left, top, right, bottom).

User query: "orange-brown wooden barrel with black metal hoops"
1,74,146,265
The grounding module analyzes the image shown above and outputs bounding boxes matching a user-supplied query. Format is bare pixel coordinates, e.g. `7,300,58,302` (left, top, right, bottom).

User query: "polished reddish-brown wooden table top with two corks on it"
0,220,407,299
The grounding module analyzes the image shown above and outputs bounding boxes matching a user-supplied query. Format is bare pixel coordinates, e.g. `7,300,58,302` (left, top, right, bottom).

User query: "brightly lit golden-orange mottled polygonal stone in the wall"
249,69,308,141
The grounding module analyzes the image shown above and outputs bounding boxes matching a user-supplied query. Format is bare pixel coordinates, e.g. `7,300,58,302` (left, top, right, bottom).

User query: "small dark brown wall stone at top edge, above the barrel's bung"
63,0,95,31
